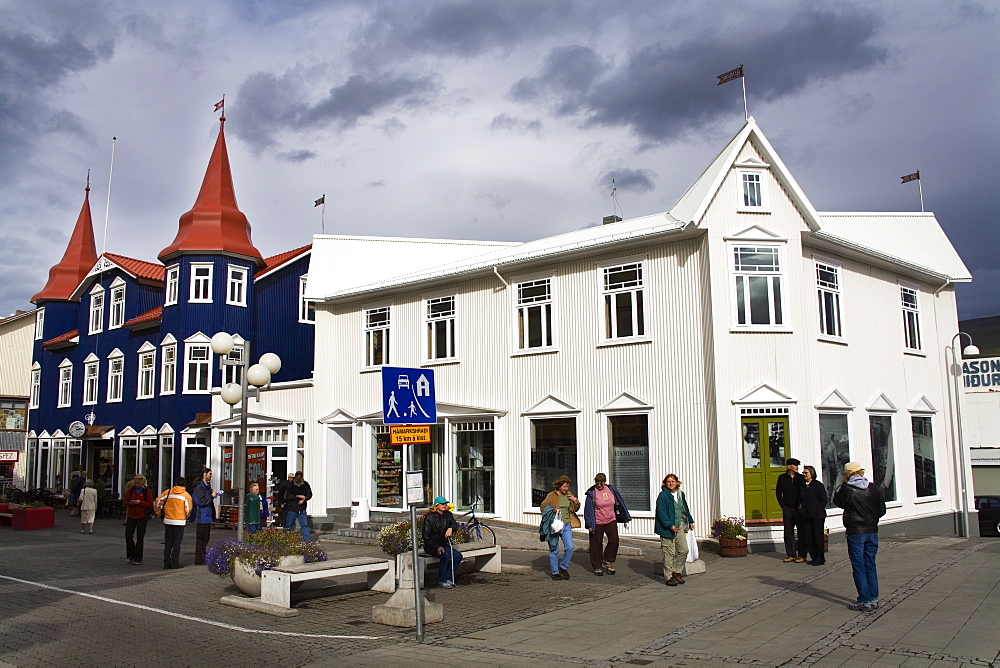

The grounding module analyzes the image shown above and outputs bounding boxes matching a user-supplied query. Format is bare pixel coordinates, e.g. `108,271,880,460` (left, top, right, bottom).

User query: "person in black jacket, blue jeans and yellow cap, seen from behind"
833,462,885,612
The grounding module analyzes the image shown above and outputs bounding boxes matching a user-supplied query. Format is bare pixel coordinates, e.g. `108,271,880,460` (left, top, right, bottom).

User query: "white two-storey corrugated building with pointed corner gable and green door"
238,119,971,544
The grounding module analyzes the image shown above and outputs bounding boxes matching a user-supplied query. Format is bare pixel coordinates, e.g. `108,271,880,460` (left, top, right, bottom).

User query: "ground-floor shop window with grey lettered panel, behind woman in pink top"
608,413,652,510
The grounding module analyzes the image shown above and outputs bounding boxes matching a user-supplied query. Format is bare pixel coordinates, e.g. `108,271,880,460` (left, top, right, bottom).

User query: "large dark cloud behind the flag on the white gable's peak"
510,8,887,142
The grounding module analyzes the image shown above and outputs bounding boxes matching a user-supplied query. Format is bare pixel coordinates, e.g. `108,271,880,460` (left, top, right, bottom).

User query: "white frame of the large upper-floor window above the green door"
727,240,792,332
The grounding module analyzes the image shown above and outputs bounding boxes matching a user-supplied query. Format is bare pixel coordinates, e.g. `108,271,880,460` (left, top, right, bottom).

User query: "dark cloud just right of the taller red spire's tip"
236,69,439,157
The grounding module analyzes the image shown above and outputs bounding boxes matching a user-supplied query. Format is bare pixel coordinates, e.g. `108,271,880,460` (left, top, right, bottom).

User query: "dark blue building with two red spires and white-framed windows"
26,116,314,498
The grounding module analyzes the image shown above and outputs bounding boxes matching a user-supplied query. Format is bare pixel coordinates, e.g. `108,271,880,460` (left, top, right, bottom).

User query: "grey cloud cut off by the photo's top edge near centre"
353,0,579,67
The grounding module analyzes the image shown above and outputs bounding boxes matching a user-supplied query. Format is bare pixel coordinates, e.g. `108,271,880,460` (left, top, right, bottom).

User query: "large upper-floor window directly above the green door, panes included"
733,245,784,327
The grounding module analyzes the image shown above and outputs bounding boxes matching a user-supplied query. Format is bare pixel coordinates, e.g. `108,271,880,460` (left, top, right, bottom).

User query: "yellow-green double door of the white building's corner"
742,417,790,520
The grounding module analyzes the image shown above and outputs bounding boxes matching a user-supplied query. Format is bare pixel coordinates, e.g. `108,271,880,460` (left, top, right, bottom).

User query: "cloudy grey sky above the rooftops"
0,0,1000,318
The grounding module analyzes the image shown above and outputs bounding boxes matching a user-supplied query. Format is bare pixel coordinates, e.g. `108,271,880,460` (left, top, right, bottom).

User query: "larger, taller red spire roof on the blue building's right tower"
159,116,264,266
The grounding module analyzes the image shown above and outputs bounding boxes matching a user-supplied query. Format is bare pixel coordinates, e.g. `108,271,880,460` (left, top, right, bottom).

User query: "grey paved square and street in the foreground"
0,511,1000,667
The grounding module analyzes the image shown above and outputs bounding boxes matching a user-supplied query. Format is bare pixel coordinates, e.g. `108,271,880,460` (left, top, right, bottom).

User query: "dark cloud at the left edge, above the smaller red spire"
0,30,113,184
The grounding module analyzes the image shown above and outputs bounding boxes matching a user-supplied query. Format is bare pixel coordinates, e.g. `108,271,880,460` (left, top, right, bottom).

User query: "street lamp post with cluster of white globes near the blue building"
212,332,281,540
